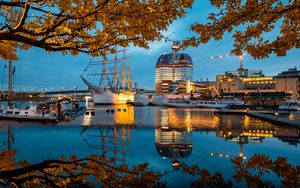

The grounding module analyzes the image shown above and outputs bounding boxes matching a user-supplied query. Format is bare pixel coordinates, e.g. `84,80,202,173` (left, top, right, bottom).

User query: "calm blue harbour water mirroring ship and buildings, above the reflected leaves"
0,106,300,184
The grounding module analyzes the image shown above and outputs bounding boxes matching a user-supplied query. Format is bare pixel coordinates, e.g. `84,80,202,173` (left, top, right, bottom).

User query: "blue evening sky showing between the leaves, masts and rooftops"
0,0,300,90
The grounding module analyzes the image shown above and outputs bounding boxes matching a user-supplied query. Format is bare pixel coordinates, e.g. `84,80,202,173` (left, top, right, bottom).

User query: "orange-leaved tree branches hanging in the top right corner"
184,0,300,59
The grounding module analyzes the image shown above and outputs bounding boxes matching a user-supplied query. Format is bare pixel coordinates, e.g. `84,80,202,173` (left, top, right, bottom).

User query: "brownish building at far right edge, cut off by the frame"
275,67,300,100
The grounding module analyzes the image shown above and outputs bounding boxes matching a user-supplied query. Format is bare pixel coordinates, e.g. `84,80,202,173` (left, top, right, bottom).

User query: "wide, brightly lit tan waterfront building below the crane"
215,66,290,106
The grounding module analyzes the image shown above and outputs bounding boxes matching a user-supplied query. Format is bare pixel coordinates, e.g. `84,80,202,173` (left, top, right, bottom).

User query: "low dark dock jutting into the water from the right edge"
214,110,300,127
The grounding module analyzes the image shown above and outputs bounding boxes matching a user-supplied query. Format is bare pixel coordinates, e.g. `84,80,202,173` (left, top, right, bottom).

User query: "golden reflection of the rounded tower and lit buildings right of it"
155,108,300,161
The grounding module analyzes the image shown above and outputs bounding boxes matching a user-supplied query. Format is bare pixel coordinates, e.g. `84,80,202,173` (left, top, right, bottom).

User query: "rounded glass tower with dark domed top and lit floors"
155,43,193,93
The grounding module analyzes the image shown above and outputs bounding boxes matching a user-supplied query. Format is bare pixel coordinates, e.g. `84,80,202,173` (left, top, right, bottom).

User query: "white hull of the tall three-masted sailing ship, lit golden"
92,89,134,105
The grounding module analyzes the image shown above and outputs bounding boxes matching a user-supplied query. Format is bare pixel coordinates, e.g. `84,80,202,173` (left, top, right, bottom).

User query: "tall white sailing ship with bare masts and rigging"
80,49,134,105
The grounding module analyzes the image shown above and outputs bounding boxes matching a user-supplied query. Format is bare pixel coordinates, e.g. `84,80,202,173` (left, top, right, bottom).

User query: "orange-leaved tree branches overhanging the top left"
0,0,193,59
